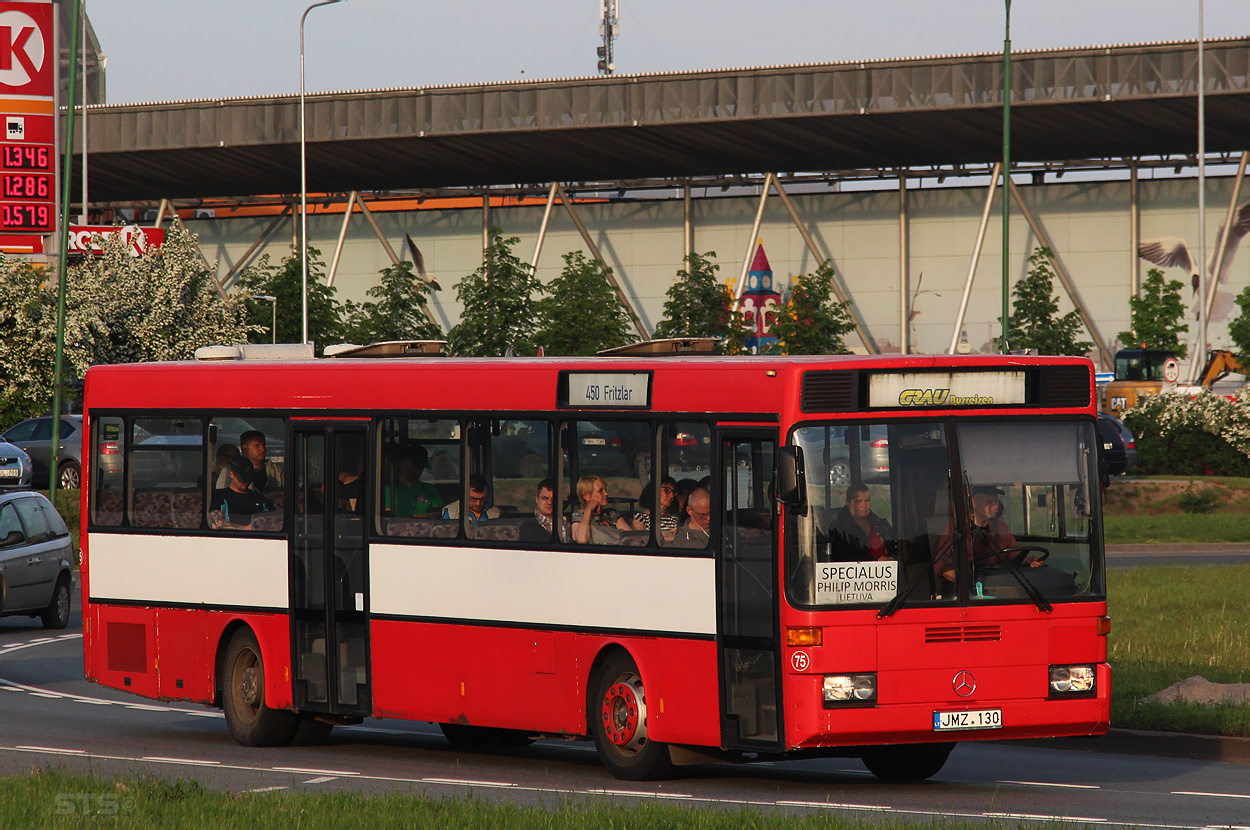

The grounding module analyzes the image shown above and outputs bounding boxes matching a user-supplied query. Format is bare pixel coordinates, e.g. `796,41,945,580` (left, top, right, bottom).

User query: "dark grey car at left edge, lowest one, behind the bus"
0,491,75,629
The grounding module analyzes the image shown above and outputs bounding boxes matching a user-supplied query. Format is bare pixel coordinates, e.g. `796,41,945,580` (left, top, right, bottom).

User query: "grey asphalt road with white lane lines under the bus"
0,614,1250,828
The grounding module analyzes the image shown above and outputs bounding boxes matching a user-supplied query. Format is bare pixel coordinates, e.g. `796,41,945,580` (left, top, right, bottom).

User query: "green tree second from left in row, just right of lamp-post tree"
343,260,443,344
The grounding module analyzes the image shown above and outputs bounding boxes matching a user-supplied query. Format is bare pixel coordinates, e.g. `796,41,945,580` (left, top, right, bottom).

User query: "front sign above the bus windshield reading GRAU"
868,371,1026,409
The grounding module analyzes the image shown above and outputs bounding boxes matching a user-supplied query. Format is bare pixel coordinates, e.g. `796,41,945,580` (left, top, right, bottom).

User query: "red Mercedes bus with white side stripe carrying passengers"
83,348,1110,779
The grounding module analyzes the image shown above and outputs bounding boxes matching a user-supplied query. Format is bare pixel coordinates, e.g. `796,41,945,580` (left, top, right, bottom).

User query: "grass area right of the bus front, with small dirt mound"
1108,565,1250,736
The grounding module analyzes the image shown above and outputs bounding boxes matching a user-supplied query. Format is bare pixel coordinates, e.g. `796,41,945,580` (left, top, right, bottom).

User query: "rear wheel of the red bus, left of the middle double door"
221,629,299,746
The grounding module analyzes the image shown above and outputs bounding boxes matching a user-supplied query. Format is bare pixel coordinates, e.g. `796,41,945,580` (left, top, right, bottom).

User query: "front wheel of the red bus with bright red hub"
586,653,674,781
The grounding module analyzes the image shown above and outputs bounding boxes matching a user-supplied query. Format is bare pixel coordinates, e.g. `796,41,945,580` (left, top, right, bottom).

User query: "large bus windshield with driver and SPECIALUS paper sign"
785,420,1104,610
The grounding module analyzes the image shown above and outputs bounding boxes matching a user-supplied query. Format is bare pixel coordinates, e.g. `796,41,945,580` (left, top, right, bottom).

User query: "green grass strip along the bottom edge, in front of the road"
0,770,1008,830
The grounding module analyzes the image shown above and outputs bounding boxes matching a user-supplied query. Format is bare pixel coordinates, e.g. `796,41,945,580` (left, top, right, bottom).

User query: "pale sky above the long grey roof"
84,0,1250,104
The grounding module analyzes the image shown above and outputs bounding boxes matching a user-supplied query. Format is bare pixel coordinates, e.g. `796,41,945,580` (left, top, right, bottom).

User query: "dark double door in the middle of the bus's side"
288,423,373,716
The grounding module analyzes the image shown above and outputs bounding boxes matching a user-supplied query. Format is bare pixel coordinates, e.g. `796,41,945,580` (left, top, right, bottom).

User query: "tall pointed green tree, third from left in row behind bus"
448,228,543,358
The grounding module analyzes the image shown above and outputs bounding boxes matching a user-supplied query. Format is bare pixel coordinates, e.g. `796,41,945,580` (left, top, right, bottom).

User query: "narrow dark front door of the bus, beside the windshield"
714,430,783,750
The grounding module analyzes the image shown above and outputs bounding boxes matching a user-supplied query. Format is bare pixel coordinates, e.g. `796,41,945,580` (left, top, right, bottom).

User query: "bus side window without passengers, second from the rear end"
126,415,205,529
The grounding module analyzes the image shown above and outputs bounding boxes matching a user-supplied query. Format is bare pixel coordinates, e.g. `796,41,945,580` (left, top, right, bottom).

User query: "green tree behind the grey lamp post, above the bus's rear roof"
239,246,345,346
